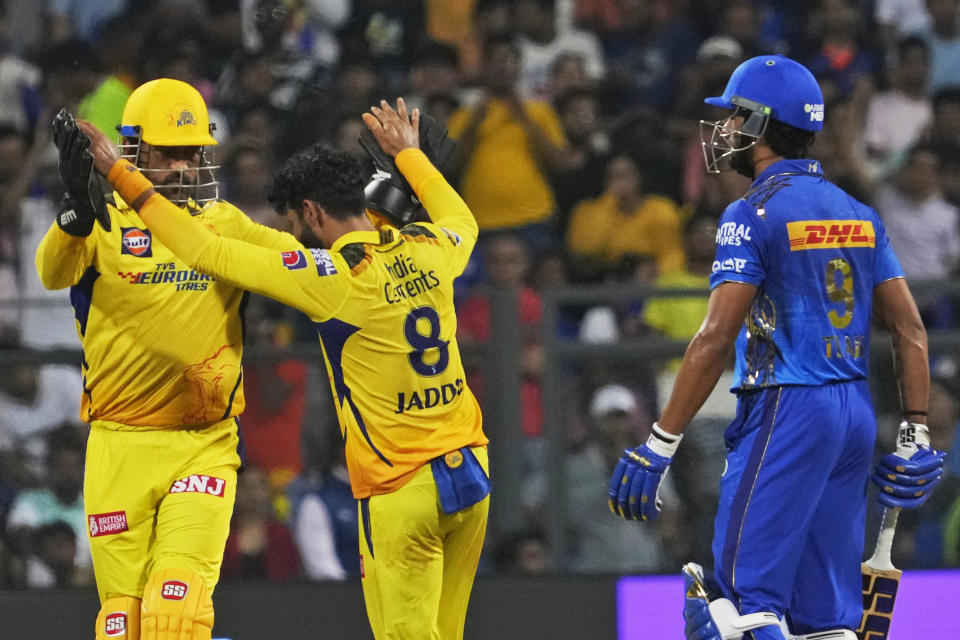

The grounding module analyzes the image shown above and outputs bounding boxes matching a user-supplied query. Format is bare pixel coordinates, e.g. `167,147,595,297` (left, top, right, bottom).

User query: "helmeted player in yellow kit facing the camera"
36,79,300,640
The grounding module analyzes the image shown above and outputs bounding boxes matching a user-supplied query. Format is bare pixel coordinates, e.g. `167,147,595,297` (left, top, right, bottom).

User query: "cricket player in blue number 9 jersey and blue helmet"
610,56,943,640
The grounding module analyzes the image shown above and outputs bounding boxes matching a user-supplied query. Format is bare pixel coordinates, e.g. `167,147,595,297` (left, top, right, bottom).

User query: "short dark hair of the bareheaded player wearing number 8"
267,144,367,220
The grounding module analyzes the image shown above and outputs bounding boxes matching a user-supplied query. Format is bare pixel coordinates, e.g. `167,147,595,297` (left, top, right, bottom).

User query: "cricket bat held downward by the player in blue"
857,508,903,640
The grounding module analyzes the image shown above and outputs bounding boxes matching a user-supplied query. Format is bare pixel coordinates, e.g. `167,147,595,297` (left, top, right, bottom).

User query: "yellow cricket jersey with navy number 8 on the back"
140,149,487,498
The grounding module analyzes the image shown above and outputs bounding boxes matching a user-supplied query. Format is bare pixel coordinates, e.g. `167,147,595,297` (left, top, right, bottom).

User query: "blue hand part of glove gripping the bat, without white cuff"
871,447,947,509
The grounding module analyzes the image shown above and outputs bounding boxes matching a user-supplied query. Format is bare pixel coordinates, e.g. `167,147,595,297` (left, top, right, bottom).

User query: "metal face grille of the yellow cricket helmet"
117,127,220,211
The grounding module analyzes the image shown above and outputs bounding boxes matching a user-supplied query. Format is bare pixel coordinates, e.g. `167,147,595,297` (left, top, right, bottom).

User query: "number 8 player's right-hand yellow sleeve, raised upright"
397,149,478,276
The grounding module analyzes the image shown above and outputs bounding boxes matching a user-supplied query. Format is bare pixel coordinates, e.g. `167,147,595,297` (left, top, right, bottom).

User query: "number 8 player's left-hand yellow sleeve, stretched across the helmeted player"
140,194,351,320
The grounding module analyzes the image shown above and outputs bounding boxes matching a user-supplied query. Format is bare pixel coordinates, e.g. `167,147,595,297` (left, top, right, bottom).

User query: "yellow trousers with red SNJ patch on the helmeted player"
83,418,240,603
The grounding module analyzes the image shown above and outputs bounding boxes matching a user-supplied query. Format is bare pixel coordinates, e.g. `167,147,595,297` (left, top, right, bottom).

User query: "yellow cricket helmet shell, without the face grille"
120,78,217,147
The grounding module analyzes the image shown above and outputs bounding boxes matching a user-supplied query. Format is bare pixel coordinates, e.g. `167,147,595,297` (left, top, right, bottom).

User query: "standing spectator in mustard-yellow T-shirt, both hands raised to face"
449,36,569,251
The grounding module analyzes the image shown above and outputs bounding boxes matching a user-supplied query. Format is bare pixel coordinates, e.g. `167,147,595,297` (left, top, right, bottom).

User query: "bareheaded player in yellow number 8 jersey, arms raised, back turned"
81,99,489,640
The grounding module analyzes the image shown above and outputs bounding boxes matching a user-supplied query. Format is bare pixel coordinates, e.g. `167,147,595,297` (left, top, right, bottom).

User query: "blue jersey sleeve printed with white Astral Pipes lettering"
710,200,766,289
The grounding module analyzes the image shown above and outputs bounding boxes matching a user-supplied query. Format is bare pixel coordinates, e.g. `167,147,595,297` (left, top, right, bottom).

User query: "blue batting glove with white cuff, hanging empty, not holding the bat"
607,422,683,520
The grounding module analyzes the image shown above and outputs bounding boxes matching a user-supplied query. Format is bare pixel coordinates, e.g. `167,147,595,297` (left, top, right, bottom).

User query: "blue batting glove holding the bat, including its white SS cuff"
872,421,947,509
